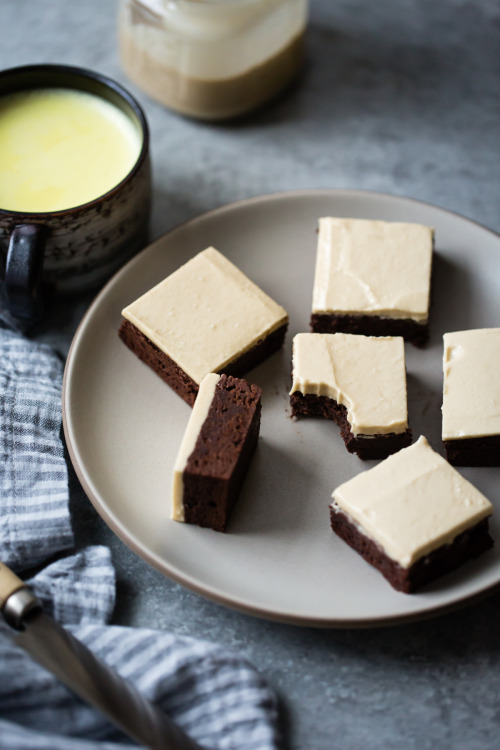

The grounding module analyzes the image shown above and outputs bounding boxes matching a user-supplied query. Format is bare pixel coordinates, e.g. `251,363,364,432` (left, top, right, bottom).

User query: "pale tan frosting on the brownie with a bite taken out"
290,333,408,435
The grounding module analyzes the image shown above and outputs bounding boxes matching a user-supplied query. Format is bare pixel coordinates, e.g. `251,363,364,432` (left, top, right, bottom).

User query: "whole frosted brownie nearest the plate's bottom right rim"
330,437,493,593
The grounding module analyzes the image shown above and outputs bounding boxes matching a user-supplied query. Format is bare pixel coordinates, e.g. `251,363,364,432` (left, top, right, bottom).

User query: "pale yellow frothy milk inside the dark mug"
0,88,142,212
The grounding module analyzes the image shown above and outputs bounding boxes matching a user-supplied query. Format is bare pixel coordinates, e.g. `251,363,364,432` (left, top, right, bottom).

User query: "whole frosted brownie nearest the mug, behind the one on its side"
119,247,288,406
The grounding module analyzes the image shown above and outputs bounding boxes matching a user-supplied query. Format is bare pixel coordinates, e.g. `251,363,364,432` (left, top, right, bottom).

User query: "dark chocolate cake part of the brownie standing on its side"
183,375,262,531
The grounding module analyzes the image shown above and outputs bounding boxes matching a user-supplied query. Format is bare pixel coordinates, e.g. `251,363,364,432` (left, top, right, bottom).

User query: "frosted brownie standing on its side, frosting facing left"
171,373,262,531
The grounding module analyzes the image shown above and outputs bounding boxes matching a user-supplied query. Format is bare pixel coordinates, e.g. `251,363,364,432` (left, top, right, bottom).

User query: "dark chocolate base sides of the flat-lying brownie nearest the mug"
118,320,287,406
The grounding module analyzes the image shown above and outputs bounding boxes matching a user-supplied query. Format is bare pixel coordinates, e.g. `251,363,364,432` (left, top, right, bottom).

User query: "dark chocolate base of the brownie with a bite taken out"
290,391,412,461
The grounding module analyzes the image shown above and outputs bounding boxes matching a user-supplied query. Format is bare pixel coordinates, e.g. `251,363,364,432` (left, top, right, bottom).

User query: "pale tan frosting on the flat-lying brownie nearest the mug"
122,247,288,383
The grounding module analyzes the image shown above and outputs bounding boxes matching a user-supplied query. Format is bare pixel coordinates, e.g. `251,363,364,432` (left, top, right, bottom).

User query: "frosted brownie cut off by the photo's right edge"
442,328,500,466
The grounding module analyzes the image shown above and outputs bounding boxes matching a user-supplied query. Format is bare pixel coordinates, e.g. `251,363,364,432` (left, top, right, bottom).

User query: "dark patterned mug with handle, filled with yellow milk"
0,65,151,328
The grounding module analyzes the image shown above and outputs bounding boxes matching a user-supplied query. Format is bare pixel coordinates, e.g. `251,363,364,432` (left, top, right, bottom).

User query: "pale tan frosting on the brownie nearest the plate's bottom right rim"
332,437,493,568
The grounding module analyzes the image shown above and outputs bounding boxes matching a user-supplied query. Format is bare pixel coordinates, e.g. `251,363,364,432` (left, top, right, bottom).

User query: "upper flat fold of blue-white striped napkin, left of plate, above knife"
0,330,73,569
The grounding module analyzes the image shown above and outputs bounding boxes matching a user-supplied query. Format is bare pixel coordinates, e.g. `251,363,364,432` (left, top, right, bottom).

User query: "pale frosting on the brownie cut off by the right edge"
442,328,500,440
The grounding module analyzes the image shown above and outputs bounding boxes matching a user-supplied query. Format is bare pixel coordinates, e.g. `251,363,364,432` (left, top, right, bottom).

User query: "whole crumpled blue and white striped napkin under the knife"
0,304,281,750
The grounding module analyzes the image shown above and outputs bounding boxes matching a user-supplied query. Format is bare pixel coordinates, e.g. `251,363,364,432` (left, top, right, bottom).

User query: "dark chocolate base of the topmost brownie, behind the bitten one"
310,313,429,346
